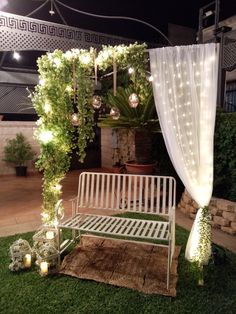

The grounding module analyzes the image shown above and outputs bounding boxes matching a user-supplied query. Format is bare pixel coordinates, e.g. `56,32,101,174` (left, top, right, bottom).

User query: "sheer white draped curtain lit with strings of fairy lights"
149,43,218,261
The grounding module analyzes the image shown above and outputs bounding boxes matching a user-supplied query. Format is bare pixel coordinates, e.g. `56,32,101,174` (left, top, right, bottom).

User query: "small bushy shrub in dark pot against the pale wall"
3,133,34,176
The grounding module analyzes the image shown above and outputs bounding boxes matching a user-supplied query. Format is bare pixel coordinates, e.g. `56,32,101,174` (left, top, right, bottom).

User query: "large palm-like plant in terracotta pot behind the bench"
99,85,160,174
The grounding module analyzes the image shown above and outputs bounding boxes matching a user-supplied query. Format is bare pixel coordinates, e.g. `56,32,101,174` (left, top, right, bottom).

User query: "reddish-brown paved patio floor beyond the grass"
0,171,236,253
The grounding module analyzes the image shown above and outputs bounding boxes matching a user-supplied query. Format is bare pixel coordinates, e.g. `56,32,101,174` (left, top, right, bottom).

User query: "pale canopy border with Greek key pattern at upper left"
0,11,134,51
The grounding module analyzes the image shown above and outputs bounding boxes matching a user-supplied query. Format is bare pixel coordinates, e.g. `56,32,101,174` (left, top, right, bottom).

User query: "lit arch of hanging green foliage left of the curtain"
31,43,150,225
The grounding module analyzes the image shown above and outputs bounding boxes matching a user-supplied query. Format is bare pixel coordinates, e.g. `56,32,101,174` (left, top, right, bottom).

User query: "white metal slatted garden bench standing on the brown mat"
58,172,176,289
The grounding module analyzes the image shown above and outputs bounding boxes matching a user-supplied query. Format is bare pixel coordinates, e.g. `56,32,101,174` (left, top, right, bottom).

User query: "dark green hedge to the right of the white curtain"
213,112,236,201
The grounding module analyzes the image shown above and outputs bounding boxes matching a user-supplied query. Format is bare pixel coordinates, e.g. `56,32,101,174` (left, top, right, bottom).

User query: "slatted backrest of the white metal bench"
77,172,176,215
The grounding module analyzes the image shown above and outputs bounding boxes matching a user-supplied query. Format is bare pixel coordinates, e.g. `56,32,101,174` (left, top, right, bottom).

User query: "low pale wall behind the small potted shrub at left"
0,121,39,175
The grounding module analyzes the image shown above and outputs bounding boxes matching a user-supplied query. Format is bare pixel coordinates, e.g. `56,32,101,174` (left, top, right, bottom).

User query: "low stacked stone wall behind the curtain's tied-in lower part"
178,190,236,235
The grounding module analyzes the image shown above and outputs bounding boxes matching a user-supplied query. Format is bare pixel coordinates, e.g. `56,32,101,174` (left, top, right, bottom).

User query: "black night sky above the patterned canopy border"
0,0,236,42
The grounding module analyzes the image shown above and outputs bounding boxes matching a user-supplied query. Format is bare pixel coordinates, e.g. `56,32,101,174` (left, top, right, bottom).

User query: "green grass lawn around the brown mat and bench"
0,213,236,314
